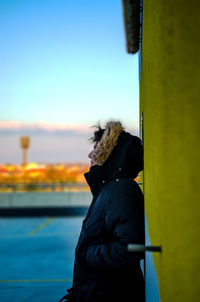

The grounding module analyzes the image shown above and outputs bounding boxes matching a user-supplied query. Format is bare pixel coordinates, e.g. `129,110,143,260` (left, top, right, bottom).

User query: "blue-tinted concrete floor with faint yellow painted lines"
0,217,83,302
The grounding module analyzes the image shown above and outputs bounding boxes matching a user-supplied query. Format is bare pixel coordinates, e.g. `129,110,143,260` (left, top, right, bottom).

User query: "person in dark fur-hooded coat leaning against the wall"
60,121,145,302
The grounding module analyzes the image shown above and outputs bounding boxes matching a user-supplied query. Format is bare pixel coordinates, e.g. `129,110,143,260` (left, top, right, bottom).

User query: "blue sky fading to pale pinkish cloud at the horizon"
0,0,139,162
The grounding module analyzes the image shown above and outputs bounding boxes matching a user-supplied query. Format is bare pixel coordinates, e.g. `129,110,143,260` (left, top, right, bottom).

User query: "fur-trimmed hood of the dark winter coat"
85,122,143,193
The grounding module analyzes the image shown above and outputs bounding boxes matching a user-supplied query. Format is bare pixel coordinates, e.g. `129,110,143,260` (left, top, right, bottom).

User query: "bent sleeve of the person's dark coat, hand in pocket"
82,188,144,269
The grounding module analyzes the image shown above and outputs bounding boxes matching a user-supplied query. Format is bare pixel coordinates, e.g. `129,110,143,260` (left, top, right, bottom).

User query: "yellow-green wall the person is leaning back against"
140,0,200,302
